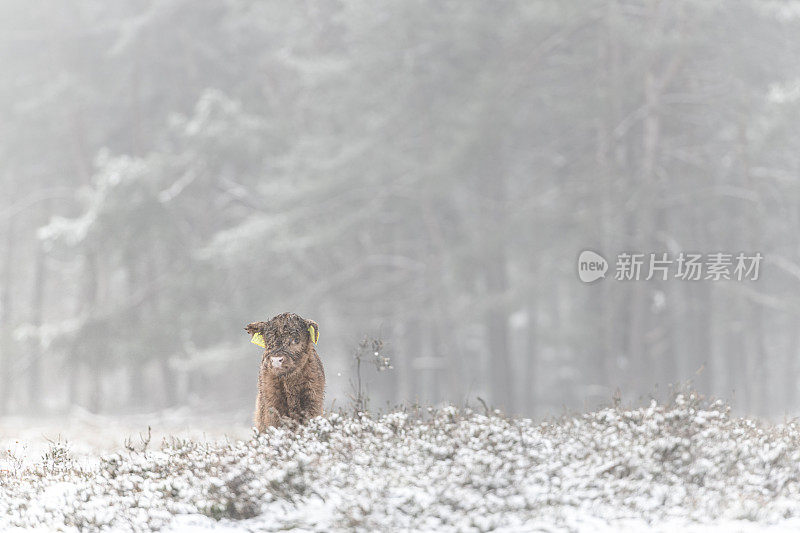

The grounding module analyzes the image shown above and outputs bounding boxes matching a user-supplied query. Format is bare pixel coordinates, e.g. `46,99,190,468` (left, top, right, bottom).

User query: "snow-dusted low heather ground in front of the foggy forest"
0,394,800,532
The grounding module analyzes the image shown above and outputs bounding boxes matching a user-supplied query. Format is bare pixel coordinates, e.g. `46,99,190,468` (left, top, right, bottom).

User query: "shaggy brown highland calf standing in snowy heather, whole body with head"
244,313,325,432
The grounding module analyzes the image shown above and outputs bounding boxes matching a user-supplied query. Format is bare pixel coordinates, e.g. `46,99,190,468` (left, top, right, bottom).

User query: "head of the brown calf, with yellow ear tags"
244,313,319,376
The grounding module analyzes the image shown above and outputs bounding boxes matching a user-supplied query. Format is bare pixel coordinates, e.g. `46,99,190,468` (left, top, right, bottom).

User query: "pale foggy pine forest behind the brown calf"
0,0,800,424
